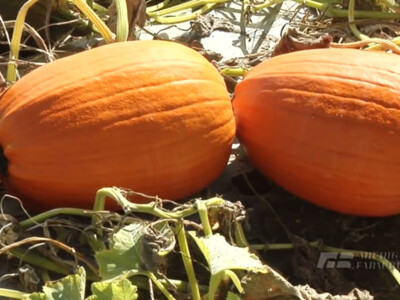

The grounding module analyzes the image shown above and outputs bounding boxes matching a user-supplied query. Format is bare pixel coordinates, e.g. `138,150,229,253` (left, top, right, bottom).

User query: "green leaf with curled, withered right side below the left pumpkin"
95,221,175,279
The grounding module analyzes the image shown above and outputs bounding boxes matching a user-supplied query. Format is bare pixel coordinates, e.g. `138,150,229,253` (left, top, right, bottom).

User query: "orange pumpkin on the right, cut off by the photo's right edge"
233,49,400,216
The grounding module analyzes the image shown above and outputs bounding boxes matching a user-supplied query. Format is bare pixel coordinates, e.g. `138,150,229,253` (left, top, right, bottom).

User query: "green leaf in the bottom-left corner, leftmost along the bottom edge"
26,267,86,300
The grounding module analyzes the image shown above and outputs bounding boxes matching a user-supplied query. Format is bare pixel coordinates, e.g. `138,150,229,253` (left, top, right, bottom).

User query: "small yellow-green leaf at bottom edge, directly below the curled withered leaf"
86,278,138,300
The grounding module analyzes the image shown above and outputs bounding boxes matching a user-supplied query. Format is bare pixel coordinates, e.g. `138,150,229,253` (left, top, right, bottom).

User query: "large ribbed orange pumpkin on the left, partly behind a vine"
0,41,236,209
